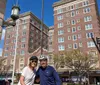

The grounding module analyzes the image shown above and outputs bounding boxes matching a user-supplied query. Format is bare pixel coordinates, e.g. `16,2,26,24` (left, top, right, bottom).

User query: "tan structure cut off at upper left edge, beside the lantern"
0,0,7,39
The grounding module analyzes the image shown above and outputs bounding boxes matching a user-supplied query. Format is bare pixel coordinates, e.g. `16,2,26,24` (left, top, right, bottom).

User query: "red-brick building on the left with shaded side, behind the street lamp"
3,12,49,72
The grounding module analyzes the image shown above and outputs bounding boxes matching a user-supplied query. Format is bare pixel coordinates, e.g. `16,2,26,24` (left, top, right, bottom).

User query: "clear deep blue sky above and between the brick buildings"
0,0,100,54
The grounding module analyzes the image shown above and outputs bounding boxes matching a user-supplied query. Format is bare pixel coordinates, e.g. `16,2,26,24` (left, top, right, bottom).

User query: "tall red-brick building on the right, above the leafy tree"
53,0,100,59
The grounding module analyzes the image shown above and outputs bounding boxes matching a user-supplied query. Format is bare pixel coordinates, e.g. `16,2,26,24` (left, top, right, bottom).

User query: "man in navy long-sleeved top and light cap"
36,56,61,85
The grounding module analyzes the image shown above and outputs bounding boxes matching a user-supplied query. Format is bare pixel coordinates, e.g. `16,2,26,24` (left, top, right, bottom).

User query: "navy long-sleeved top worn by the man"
36,66,61,85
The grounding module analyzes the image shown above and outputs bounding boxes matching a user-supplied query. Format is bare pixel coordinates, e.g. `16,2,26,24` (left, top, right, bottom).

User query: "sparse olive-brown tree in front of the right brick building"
54,50,98,85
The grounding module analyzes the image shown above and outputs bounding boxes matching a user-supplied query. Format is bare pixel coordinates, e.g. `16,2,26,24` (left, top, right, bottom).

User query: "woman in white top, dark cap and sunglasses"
18,56,38,85
